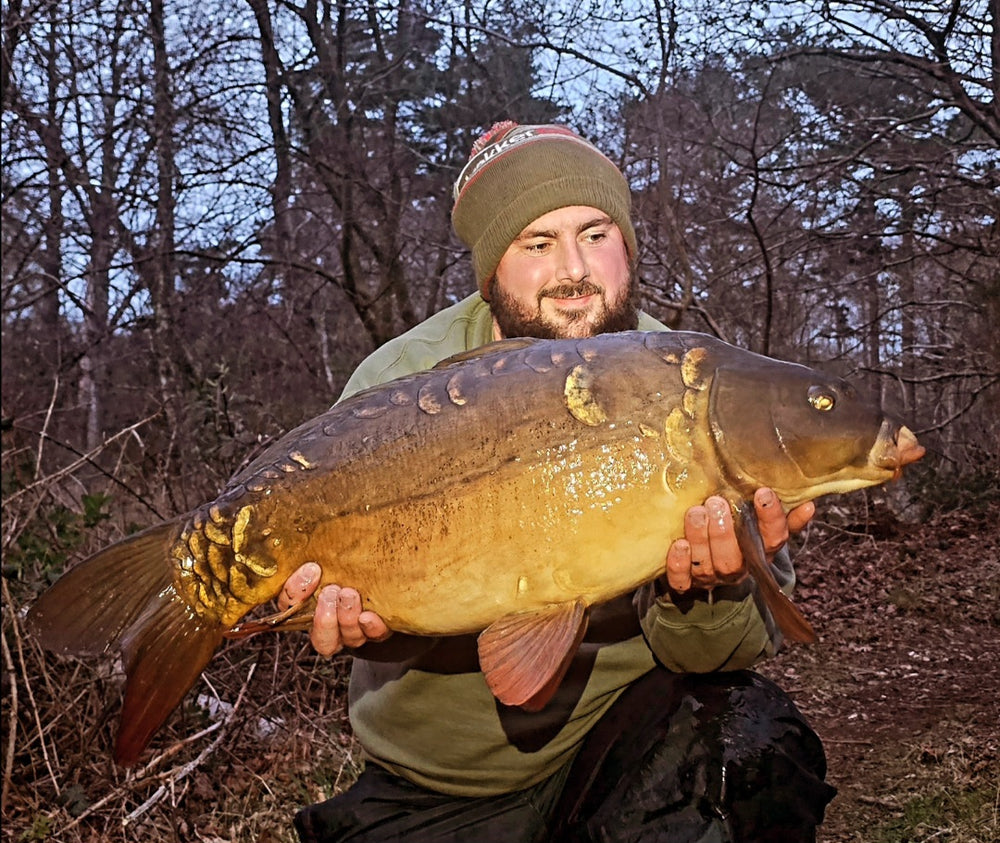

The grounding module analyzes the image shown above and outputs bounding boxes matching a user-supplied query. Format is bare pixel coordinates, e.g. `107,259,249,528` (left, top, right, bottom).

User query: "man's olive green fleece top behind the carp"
341,293,794,796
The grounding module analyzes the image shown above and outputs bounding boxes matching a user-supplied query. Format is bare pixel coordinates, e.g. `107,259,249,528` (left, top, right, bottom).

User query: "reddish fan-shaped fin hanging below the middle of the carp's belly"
479,600,588,711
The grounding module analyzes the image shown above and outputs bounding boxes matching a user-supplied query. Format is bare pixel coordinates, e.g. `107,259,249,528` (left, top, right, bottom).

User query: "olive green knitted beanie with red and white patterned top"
451,120,637,298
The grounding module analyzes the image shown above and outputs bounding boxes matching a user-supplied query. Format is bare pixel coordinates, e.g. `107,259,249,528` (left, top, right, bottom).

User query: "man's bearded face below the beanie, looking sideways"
490,205,639,339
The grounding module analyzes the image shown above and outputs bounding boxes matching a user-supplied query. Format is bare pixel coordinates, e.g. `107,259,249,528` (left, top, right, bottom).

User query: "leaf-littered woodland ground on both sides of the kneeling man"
2,504,1000,843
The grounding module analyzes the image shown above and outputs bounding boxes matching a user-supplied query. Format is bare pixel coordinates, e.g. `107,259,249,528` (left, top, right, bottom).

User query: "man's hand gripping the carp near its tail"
278,562,392,656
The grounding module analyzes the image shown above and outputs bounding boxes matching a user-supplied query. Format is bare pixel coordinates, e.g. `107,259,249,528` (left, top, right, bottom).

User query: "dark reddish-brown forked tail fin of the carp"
27,519,223,765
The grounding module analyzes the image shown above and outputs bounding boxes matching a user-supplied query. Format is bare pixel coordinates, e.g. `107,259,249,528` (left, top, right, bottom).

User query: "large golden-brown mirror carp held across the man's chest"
28,332,924,764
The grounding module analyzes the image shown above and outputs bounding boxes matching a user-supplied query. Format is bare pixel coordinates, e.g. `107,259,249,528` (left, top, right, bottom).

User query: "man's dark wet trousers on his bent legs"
295,669,836,843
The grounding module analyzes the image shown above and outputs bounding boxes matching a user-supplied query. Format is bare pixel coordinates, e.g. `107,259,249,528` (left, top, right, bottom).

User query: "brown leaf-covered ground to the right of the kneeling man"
763,498,1000,843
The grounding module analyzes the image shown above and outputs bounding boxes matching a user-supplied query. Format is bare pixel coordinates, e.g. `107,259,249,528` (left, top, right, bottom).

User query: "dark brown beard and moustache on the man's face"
490,275,639,340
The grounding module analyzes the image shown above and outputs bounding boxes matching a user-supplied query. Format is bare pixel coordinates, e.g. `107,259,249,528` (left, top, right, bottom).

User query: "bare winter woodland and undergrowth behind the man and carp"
0,0,1000,840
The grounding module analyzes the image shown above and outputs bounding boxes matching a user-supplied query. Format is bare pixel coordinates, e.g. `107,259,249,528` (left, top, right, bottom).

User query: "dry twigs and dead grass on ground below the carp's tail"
3,590,366,843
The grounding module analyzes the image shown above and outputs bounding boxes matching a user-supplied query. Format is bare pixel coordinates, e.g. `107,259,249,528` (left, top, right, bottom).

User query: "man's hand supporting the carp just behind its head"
667,489,816,594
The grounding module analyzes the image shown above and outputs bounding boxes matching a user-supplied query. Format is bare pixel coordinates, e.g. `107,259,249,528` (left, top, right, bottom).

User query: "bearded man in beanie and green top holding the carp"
279,123,833,843
